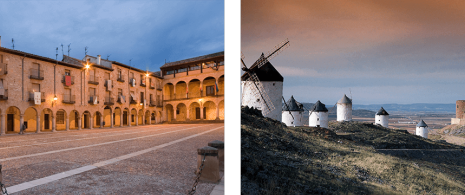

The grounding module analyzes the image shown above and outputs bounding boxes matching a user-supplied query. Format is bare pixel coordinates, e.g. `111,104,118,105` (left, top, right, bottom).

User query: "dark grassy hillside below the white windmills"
240,107,465,194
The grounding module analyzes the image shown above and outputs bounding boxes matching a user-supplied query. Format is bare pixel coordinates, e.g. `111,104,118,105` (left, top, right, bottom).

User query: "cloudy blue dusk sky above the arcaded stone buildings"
0,0,225,71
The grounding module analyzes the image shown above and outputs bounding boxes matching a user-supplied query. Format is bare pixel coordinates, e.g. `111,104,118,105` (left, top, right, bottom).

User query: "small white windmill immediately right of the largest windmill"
282,96,304,127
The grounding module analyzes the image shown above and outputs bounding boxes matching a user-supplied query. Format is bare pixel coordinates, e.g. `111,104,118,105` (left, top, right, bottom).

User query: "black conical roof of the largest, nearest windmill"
241,53,284,82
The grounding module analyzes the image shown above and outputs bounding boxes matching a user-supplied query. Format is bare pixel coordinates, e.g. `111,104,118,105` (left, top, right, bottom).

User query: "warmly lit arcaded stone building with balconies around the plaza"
0,37,224,134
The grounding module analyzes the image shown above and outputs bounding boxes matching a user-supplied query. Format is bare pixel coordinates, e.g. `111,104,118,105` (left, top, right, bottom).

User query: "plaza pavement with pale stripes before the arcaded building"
0,123,224,194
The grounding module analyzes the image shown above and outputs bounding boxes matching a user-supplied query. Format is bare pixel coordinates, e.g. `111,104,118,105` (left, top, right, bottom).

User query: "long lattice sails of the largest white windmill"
240,39,290,115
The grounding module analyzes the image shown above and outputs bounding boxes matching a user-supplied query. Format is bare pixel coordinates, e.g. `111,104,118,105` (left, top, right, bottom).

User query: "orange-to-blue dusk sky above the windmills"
241,0,465,106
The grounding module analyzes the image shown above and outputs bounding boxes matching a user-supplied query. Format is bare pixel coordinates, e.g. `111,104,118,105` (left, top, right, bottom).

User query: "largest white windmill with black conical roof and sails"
241,39,289,121
